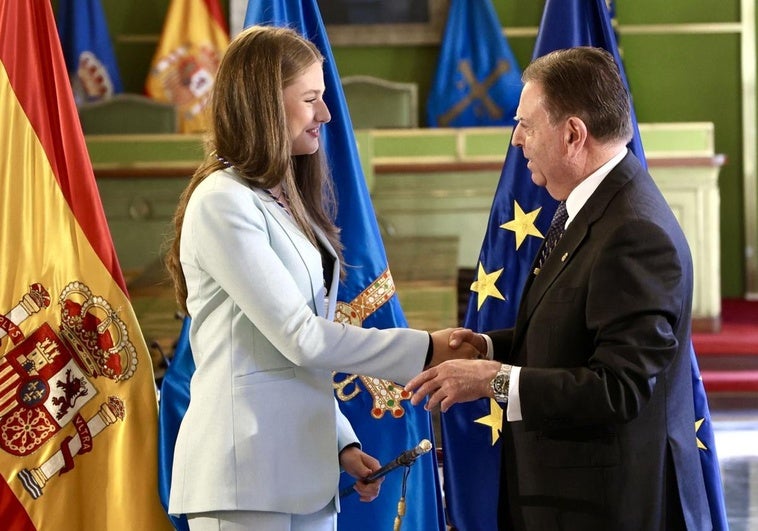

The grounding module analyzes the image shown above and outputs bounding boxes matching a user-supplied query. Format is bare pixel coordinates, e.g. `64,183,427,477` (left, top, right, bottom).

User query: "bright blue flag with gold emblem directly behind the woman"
245,0,445,531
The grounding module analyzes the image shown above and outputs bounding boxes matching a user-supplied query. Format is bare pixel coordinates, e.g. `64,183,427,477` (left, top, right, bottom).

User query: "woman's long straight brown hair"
165,26,342,312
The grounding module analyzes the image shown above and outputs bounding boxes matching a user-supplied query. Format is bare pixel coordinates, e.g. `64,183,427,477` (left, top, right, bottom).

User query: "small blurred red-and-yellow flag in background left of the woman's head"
145,0,229,133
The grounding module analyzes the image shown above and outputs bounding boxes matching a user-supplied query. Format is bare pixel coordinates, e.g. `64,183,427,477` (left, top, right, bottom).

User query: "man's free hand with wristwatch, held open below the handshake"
405,359,501,412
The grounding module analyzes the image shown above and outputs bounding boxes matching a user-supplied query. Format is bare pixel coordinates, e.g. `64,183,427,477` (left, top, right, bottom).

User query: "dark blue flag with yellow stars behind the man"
442,0,696,531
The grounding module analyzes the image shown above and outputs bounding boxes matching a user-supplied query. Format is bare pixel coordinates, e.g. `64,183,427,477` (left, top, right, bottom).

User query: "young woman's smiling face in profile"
283,61,332,156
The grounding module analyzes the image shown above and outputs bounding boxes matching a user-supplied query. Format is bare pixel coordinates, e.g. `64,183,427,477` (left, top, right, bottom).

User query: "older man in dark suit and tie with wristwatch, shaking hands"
407,47,711,531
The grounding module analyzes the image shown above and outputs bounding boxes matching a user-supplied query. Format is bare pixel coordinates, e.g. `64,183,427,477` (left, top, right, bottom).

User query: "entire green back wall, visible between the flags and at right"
77,0,745,297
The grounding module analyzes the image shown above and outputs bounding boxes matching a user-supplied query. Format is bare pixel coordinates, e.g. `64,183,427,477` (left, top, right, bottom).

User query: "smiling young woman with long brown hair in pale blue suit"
167,27,475,531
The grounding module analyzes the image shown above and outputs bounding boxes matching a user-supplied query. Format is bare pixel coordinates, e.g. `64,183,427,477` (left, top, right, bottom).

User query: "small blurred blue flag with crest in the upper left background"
58,0,124,105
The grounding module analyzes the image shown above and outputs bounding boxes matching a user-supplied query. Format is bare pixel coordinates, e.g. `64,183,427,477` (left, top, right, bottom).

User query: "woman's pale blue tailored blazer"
169,169,429,514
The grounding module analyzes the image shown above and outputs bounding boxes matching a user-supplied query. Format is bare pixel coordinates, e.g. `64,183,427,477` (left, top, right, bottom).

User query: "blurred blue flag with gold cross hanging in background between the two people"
427,0,521,127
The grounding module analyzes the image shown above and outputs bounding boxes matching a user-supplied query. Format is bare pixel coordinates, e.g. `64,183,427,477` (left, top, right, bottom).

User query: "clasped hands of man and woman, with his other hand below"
405,328,508,412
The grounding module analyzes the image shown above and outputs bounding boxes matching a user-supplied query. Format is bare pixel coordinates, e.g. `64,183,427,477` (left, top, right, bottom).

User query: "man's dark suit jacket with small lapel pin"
488,154,711,531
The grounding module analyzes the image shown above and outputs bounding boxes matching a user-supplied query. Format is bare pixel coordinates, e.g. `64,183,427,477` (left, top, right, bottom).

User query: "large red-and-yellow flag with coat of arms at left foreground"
0,0,170,531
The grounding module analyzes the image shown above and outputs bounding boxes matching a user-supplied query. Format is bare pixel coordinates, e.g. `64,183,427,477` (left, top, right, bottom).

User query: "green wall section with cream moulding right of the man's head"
617,0,745,297
